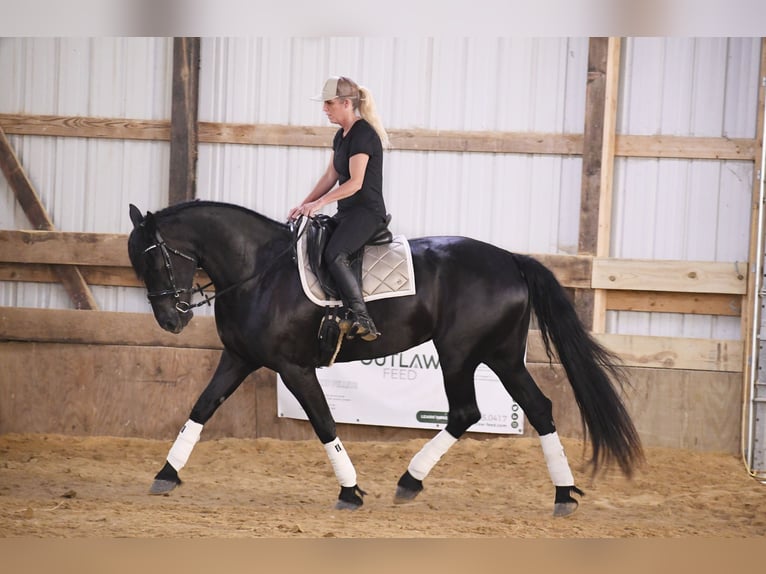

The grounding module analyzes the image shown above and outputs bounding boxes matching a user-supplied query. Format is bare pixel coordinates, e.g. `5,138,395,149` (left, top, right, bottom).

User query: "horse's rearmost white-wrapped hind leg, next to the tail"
486,358,583,516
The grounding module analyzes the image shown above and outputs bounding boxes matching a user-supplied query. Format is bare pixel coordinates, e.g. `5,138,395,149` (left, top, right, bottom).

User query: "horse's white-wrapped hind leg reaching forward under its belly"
394,362,481,503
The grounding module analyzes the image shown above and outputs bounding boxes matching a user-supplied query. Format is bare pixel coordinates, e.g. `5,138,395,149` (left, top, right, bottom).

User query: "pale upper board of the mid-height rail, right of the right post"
592,258,748,295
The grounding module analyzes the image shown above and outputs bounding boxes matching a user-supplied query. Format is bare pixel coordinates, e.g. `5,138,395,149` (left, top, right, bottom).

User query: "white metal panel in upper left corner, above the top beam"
0,38,173,119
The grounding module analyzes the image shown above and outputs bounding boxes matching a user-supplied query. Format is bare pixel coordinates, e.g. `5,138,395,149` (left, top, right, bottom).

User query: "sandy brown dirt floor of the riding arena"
0,434,766,539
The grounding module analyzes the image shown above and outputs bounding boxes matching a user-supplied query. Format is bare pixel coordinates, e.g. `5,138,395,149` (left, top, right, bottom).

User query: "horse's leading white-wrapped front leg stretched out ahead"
149,350,255,494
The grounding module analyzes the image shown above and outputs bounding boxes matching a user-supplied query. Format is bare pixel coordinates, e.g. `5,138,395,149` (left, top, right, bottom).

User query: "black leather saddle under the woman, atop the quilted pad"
306,214,393,299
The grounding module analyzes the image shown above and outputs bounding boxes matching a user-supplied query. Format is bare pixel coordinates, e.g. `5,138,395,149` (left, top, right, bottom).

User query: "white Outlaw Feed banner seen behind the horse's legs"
277,341,524,434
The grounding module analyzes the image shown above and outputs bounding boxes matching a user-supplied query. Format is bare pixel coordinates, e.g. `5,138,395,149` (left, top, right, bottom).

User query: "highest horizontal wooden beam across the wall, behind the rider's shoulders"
0,114,760,161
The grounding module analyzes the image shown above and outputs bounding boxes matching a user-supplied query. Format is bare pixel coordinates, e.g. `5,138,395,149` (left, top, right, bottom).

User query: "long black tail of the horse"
514,254,644,476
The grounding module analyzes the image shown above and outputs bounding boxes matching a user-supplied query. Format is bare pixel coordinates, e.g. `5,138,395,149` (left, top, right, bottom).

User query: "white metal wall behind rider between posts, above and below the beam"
198,38,588,253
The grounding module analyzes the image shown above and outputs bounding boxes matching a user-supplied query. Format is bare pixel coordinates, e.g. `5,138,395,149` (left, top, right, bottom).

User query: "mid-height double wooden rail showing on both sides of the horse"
0,230,747,322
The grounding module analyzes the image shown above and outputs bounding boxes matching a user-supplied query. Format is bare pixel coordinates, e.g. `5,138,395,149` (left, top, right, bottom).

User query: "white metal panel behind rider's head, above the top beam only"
200,38,588,133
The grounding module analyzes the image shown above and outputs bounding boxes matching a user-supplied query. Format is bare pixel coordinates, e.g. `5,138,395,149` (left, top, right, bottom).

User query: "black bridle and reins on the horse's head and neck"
144,216,308,313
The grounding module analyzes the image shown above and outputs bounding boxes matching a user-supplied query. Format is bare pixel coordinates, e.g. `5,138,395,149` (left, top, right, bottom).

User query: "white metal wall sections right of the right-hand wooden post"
608,38,760,339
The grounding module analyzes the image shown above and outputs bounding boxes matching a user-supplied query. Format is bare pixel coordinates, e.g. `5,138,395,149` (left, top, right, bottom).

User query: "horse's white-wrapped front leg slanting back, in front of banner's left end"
279,365,366,510
